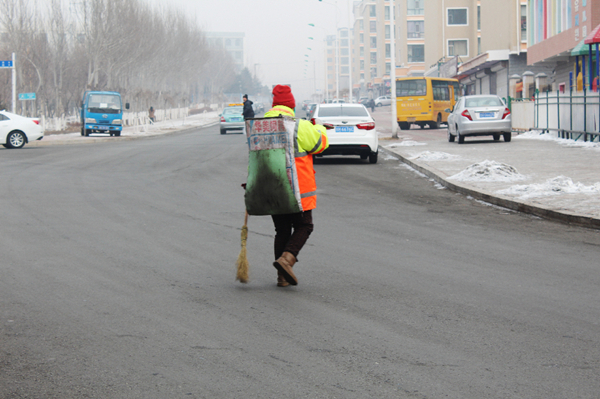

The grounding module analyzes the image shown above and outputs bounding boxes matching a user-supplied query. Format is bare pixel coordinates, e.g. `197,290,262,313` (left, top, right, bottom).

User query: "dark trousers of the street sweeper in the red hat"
271,210,314,259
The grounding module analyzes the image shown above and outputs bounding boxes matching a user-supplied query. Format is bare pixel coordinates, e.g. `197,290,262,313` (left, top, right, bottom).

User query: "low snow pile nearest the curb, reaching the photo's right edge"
498,176,600,199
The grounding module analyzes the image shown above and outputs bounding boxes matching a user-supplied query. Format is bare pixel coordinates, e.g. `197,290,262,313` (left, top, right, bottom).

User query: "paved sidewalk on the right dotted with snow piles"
372,107,600,228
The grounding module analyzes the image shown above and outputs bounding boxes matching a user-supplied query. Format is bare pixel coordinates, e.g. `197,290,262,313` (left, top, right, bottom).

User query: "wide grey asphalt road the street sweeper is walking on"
0,126,600,399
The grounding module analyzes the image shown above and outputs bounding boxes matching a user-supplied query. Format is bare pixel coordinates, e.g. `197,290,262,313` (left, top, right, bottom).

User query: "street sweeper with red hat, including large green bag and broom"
238,85,329,287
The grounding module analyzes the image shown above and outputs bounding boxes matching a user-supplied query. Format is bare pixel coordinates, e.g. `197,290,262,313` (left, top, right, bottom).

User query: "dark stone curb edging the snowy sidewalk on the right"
379,146,600,229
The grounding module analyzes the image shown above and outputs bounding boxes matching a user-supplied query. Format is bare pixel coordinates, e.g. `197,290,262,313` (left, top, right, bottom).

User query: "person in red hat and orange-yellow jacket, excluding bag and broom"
264,85,329,287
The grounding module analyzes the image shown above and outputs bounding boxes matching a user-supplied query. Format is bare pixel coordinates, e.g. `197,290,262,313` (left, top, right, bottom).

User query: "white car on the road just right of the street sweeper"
311,104,379,163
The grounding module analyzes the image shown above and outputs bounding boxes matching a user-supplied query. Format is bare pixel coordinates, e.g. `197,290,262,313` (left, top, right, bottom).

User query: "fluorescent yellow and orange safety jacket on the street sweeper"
265,105,329,211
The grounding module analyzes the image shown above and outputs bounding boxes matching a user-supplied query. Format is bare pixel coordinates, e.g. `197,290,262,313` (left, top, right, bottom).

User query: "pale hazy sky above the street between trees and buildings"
141,0,352,101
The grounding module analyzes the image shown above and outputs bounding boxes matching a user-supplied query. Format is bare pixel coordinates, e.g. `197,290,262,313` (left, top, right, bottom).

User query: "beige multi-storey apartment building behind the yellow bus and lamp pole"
352,0,540,95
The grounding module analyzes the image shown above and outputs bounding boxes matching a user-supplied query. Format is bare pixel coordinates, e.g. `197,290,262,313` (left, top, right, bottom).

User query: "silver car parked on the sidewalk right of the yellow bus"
445,94,512,144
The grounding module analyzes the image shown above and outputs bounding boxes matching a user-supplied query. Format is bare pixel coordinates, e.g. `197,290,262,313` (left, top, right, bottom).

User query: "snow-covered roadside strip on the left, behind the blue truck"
26,112,219,147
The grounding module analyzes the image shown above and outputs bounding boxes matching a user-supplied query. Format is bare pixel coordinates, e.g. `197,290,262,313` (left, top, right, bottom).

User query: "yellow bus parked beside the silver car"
396,76,459,130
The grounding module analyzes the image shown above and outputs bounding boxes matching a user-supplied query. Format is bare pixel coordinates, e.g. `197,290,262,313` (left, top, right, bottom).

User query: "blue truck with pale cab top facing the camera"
81,91,129,136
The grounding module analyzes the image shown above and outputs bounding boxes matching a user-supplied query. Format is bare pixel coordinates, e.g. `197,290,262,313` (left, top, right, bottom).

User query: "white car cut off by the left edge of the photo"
0,111,44,148
